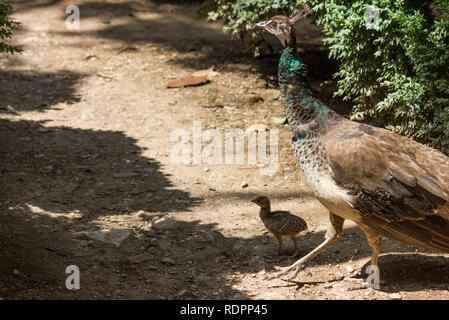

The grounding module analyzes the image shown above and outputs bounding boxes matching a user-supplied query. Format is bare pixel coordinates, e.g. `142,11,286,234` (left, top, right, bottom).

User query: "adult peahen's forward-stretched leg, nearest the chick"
265,212,345,280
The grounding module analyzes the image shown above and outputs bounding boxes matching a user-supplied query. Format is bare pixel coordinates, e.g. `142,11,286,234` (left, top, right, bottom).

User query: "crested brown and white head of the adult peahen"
254,5,312,47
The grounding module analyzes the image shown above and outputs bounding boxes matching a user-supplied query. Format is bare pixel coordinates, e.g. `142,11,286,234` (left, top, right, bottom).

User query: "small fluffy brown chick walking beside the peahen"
251,196,307,257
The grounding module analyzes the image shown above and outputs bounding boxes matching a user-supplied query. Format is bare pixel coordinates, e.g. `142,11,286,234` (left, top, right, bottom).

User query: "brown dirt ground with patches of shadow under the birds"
0,0,449,299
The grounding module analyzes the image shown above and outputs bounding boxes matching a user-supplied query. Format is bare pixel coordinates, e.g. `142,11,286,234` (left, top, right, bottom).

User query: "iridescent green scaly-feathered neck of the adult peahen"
279,45,336,139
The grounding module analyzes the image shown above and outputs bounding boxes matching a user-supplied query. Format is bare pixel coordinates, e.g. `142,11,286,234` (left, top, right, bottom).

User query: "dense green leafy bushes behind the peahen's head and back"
209,0,449,154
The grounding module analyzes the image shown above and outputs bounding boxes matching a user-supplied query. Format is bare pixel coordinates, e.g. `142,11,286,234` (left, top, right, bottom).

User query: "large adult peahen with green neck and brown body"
255,6,449,284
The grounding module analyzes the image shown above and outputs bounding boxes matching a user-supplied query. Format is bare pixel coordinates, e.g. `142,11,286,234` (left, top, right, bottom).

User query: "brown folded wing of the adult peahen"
322,121,449,252
